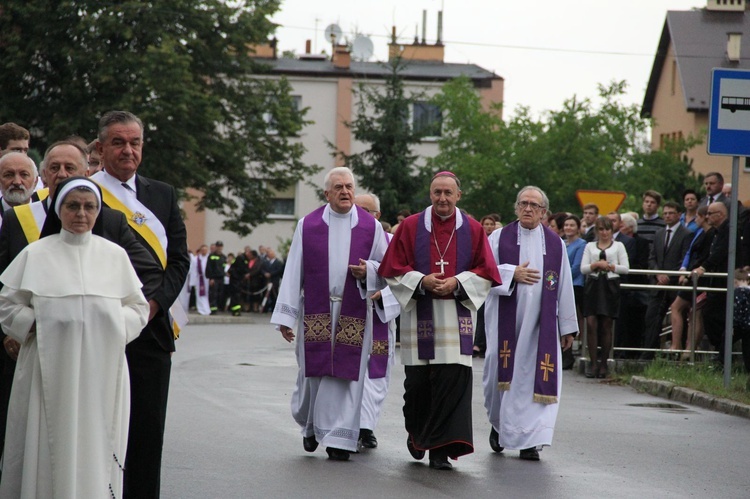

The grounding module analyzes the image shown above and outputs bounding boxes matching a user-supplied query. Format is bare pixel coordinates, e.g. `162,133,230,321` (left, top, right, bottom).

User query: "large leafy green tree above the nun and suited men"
0,0,317,235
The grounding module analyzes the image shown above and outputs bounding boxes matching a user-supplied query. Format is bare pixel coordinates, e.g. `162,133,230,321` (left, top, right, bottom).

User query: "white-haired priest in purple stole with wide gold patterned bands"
271,167,387,461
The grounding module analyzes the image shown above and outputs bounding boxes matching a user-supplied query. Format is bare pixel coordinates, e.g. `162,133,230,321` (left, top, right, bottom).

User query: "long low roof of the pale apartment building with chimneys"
257,58,503,84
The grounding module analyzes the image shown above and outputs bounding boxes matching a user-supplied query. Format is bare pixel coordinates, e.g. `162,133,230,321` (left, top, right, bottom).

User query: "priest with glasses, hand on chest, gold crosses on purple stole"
483,186,578,461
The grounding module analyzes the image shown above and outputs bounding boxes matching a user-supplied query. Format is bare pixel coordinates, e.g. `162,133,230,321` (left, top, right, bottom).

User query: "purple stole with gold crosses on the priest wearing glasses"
497,220,562,404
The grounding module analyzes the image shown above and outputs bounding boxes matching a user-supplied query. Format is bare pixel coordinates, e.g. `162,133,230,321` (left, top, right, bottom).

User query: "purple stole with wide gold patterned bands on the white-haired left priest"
302,206,375,381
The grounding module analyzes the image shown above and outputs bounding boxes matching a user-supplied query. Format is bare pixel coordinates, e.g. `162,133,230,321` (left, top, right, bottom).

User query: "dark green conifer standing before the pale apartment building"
329,58,428,221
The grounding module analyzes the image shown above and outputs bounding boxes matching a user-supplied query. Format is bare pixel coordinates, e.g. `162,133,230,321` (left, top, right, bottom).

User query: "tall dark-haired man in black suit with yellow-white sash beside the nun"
91,111,190,499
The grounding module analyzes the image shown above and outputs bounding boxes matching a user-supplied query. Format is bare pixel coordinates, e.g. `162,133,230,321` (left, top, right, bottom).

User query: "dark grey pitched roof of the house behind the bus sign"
641,9,750,117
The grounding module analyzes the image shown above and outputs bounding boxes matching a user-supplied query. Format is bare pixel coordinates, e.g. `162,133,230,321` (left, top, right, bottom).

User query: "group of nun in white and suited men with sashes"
0,111,190,499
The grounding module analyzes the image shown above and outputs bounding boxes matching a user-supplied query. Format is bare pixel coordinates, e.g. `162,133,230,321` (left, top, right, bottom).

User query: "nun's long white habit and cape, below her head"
0,230,149,498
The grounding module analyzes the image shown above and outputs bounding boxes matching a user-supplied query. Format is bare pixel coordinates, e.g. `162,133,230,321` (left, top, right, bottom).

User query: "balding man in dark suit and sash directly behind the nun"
0,141,161,464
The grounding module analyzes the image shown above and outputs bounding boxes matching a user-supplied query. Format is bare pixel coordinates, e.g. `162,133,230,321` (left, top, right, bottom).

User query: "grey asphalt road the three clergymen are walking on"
162,324,750,499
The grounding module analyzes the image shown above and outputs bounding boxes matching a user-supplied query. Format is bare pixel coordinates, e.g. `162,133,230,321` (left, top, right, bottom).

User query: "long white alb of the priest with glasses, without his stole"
483,224,578,449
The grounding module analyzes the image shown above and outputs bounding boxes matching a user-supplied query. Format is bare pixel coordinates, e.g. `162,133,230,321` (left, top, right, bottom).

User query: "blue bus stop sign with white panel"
708,68,750,156
